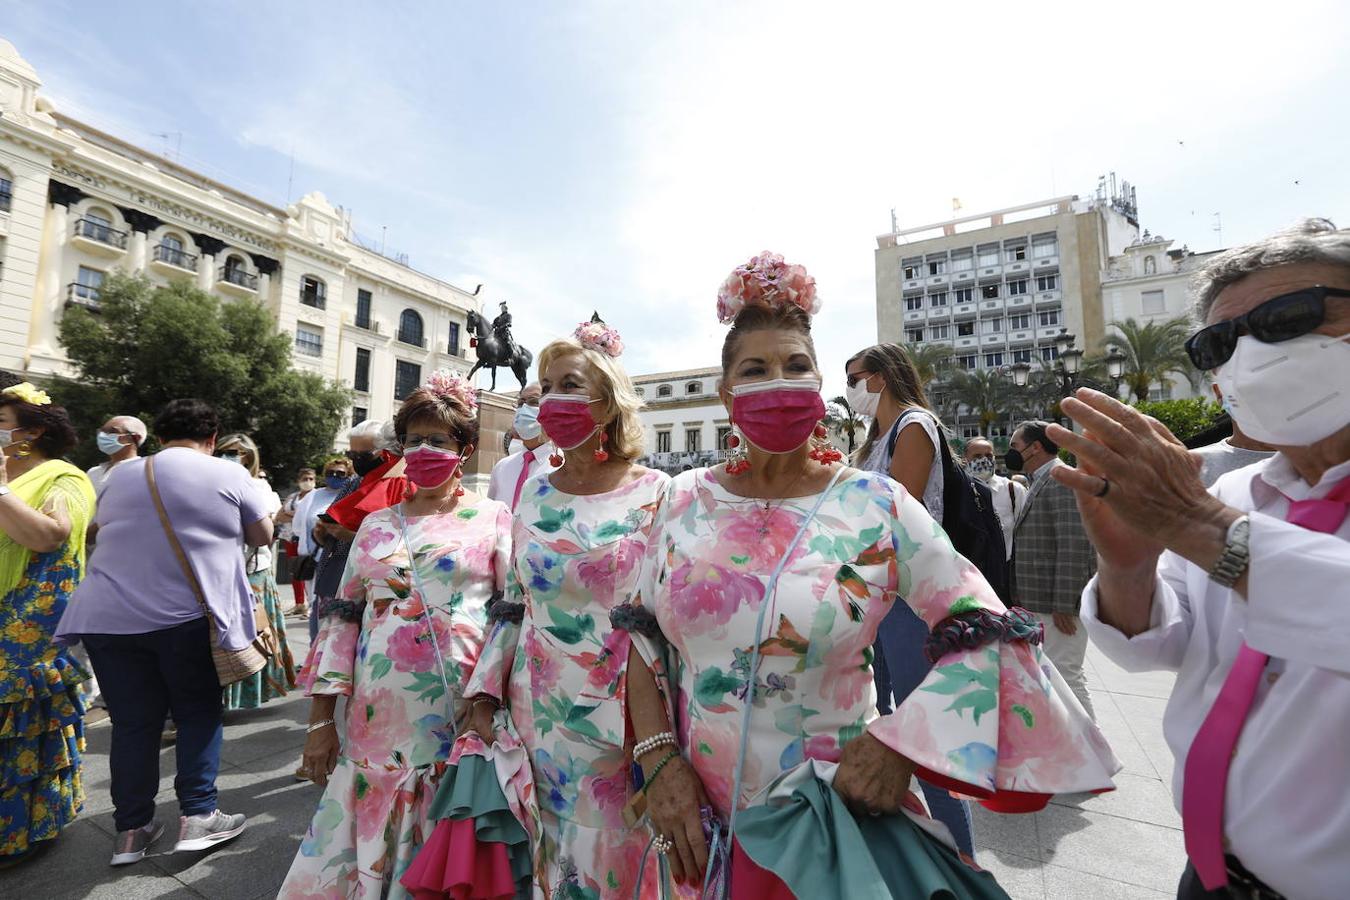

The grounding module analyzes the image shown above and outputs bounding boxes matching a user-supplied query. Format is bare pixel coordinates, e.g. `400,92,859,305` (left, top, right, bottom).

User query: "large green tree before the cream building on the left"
51,275,351,482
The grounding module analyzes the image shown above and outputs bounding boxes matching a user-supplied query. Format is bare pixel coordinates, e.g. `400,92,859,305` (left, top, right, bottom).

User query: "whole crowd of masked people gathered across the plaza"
0,220,1350,900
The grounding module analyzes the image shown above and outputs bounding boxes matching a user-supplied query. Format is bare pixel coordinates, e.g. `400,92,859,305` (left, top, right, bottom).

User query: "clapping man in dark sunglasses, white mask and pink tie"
1050,220,1350,900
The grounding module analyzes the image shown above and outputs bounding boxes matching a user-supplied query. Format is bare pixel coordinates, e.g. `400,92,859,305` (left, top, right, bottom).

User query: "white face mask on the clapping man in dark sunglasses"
1216,335,1350,447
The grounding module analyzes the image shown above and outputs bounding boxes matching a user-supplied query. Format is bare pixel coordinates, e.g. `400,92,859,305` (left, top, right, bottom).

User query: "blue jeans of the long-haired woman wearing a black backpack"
872,599,975,857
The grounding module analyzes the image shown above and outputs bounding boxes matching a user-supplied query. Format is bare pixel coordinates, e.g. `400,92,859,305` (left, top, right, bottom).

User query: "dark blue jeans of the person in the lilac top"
81,618,223,831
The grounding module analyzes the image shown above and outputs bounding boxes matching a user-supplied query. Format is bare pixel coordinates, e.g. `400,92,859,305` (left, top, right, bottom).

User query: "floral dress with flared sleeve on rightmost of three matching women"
635,470,1119,818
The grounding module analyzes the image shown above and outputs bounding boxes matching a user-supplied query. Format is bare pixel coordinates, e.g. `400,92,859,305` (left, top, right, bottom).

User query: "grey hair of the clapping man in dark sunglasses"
1192,219,1350,327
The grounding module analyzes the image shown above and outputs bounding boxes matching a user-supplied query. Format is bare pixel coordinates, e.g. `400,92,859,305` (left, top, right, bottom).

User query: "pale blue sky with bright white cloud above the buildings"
0,0,1350,390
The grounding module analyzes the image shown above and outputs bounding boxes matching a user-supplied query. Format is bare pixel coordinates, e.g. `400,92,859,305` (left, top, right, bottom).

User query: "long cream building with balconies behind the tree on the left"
0,40,479,437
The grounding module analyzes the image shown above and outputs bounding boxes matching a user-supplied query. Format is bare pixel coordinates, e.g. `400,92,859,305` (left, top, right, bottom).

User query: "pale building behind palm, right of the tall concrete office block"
1102,232,1222,399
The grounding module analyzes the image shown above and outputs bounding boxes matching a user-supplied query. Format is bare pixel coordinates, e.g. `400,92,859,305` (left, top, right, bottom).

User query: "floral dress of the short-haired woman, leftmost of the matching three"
279,499,510,900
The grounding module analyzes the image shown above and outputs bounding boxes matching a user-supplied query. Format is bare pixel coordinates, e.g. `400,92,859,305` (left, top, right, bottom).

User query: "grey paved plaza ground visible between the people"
0,623,1185,900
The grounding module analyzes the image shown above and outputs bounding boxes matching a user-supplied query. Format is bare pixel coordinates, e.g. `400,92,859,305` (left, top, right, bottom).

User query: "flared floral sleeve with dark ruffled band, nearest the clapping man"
868,486,1121,812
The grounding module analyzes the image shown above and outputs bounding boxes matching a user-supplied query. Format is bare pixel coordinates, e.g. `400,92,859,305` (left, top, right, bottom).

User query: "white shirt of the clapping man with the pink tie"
1083,453,1350,900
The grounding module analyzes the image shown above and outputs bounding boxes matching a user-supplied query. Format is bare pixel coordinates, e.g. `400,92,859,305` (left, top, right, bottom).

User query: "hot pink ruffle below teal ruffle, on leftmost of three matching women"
398,819,516,900
